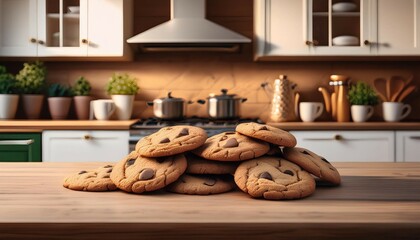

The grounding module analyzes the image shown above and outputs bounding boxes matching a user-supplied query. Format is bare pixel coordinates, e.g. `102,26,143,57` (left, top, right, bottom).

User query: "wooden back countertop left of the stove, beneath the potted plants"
0,119,138,132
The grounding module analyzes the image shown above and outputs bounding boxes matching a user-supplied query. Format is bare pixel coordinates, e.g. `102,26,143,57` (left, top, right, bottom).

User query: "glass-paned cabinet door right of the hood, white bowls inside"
307,0,371,56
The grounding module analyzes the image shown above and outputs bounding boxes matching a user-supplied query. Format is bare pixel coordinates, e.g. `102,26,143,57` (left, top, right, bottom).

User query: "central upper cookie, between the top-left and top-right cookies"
192,132,270,161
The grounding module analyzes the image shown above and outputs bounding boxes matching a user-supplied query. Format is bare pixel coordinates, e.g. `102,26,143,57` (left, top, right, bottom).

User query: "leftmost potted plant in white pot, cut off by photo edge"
0,65,19,119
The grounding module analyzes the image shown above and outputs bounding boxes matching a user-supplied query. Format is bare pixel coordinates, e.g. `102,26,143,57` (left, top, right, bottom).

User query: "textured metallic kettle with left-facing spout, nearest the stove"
261,75,300,122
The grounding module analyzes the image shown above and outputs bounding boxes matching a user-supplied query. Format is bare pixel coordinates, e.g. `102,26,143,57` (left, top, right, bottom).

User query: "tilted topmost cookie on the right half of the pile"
236,122,296,147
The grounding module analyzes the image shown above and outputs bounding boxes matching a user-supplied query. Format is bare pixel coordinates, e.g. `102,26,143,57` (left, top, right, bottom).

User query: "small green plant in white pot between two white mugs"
348,81,378,122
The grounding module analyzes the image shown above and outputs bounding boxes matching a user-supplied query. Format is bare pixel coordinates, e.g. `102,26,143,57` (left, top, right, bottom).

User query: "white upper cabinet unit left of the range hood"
0,0,132,57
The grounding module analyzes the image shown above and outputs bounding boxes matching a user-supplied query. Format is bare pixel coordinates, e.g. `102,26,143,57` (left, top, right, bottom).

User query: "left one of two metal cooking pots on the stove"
147,92,192,120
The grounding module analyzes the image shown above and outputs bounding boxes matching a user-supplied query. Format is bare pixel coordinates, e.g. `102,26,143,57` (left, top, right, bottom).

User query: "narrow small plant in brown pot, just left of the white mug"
73,76,92,120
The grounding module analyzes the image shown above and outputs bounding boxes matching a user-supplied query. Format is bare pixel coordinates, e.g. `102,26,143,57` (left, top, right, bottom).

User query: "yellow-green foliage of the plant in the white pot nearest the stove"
106,73,139,95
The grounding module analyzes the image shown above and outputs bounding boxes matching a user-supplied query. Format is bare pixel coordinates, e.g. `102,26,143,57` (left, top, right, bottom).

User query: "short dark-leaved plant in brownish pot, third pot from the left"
48,83,73,120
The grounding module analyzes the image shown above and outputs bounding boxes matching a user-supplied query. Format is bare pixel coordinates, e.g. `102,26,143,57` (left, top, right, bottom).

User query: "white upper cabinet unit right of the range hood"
254,0,420,60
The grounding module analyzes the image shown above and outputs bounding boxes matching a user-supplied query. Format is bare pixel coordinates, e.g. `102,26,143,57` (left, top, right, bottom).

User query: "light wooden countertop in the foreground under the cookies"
0,163,420,240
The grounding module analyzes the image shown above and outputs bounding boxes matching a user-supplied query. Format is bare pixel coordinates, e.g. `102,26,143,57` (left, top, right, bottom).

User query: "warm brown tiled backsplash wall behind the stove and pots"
37,57,420,120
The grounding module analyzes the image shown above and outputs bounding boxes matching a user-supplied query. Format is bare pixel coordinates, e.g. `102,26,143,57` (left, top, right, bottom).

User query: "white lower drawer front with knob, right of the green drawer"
42,130,129,162
